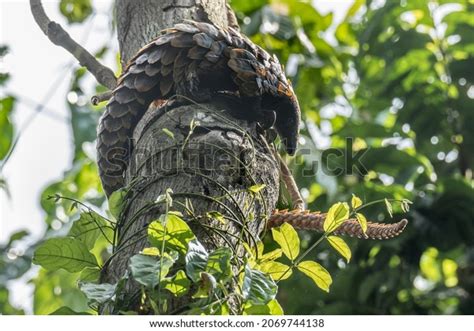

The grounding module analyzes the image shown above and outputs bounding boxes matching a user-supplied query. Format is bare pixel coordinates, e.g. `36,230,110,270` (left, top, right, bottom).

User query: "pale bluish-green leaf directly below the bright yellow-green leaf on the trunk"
130,252,178,289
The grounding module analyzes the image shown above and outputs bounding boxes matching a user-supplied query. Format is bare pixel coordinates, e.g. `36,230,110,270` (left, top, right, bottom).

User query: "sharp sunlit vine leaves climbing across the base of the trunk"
27,190,404,315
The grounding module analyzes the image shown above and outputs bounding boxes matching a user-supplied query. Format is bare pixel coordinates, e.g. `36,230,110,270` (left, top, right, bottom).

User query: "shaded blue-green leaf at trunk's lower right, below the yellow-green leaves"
242,264,278,305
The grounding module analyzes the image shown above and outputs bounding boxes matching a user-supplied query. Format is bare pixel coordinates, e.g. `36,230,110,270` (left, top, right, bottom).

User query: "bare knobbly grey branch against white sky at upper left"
30,0,117,90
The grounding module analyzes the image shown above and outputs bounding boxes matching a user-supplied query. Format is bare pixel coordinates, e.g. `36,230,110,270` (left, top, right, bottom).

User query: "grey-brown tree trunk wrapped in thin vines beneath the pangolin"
103,0,279,313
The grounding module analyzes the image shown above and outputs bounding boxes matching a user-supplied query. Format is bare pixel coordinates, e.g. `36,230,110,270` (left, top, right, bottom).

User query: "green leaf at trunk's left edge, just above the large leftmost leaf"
68,212,111,250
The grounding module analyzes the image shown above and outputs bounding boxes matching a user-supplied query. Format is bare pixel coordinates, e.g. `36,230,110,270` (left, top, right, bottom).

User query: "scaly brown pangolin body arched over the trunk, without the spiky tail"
97,21,300,195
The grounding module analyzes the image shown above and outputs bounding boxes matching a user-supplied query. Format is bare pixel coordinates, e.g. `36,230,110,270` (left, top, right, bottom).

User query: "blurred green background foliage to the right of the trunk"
232,0,474,314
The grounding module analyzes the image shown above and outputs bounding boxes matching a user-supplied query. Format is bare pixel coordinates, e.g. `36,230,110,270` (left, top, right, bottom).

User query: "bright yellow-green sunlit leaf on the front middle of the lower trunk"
148,213,195,254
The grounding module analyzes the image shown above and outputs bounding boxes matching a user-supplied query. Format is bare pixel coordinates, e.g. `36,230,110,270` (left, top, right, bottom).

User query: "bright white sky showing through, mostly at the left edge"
0,0,353,312
